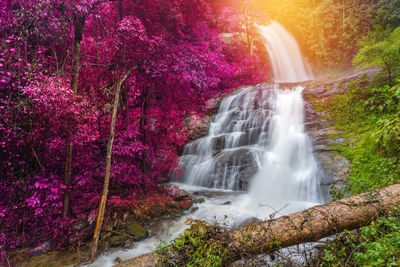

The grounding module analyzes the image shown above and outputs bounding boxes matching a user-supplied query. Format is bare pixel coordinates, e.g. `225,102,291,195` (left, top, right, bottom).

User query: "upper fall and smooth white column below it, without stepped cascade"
250,22,322,203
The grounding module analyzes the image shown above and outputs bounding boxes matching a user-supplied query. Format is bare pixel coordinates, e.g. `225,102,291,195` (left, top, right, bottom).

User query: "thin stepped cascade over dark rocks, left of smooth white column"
180,86,273,190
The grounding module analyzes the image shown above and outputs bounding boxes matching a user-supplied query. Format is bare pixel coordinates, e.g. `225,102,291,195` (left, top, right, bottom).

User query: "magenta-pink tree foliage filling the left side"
0,0,267,260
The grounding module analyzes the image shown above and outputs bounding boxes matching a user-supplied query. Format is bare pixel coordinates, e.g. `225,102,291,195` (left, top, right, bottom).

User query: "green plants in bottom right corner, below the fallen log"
322,208,400,266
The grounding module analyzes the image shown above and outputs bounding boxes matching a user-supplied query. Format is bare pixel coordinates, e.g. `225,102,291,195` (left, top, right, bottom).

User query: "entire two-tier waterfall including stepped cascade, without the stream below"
180,22,322,204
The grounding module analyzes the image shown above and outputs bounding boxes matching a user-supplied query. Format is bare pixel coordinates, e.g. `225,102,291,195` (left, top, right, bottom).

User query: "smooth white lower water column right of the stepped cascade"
249,86,322,206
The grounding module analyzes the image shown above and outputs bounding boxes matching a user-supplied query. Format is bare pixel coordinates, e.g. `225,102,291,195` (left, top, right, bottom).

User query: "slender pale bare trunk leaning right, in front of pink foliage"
89,66,137,261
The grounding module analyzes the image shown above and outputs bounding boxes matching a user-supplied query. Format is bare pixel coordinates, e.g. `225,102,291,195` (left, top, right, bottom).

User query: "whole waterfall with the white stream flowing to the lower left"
90,22,322,267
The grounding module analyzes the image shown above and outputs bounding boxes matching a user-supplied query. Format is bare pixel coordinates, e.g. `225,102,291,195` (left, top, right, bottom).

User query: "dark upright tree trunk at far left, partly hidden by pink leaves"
63,16,86,217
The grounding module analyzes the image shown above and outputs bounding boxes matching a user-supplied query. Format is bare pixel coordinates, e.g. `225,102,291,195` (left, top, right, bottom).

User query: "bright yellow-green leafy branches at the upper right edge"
353,25,400,84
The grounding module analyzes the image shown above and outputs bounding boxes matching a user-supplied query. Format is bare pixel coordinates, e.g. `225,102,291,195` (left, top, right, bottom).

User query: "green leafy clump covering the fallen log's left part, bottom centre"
157,221,228,266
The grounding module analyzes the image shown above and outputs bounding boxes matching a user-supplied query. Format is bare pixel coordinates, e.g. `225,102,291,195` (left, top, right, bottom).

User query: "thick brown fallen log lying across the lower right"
116,183,400,267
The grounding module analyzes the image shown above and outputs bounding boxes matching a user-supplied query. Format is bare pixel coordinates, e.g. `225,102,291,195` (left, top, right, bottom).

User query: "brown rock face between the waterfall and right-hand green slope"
303,69,378,201
